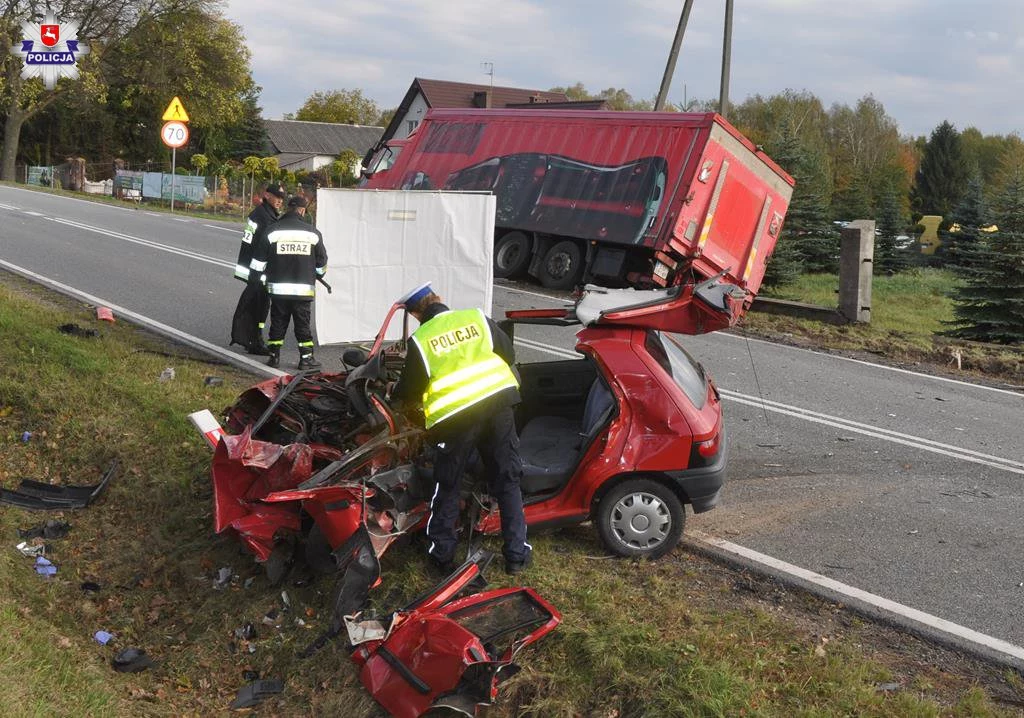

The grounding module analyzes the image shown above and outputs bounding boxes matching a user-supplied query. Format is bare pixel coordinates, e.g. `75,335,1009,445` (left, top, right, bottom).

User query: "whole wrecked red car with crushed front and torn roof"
212,278,724,579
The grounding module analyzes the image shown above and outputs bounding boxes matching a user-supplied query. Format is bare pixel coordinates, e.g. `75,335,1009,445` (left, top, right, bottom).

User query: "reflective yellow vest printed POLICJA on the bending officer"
412,309,519,429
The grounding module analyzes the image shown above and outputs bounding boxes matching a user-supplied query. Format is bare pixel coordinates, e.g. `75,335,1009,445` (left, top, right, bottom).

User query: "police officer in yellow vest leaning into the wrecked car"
391,284,531,574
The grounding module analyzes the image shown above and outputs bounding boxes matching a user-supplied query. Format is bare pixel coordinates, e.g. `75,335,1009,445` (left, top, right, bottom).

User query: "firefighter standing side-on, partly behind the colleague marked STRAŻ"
230,184,286,355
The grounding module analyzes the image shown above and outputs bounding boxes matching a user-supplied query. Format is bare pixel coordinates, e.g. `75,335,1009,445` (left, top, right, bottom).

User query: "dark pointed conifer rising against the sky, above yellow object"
912,121,968,217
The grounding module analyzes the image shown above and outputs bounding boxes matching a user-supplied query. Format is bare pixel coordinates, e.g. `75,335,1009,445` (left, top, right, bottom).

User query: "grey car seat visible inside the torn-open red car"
519,377,615,495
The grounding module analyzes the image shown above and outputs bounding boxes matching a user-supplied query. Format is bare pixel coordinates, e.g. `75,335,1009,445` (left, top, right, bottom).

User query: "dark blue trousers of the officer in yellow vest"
427,407,530,563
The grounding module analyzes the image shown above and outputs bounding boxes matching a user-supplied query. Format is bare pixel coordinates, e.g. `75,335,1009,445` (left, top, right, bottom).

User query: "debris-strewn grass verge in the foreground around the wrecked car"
0,276,1020,717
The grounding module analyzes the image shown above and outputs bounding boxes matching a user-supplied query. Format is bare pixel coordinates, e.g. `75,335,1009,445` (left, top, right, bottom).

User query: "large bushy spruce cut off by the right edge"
946,165,1024,344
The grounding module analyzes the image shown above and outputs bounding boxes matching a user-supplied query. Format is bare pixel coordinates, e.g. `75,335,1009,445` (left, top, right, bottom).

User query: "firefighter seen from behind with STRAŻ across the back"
249,197,327,369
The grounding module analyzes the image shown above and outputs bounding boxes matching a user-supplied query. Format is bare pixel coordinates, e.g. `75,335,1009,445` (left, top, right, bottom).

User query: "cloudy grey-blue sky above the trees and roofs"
225,0,1024,135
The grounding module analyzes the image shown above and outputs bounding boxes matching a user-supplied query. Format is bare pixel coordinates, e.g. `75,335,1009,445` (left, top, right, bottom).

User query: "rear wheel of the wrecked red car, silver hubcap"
596,478,686,558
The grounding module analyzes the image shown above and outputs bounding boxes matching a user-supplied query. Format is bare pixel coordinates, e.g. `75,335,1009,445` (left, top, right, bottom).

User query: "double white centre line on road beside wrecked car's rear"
515,338,1024,475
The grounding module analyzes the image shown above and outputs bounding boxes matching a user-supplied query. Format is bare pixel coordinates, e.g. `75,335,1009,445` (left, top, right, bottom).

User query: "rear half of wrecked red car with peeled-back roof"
491,288,726,558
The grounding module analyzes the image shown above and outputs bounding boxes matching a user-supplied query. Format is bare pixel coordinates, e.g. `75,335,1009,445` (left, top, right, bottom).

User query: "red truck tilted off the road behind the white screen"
364,109,793,311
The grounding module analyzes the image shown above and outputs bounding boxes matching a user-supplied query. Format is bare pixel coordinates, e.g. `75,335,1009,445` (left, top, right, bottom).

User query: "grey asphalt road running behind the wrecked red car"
0,186,1024,645
